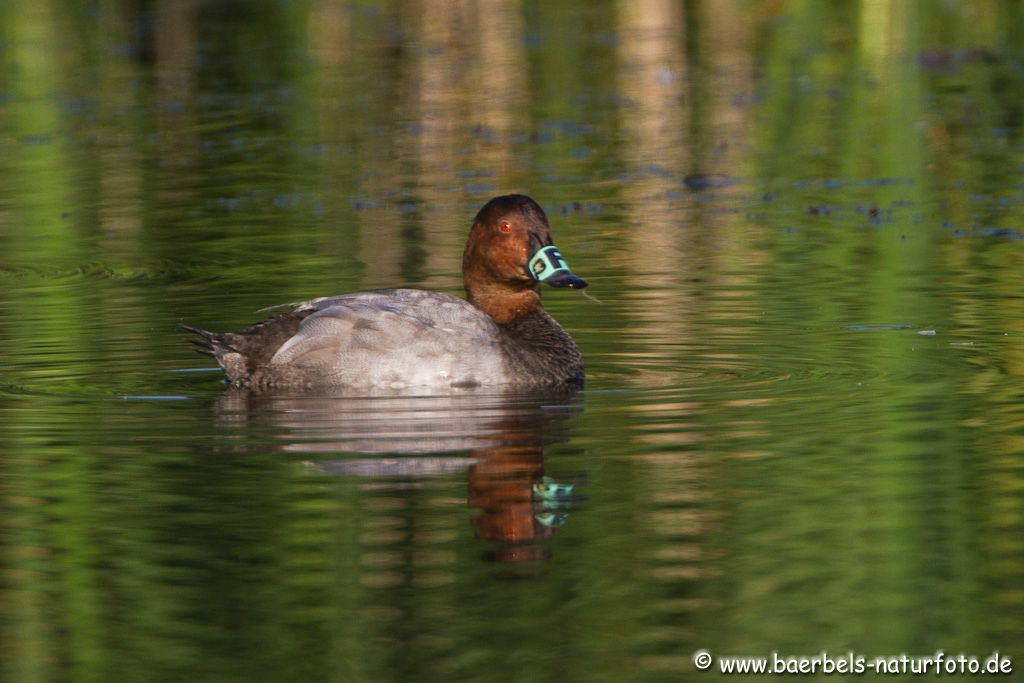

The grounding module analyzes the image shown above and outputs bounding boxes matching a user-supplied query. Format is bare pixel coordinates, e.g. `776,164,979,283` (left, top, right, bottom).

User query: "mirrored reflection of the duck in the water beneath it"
209,387,583,562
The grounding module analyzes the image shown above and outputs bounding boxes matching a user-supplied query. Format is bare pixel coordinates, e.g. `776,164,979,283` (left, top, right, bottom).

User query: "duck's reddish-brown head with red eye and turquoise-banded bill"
462,195,587,323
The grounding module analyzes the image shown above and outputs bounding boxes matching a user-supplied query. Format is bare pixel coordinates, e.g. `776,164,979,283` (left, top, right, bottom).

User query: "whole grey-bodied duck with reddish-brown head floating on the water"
181,195,588,390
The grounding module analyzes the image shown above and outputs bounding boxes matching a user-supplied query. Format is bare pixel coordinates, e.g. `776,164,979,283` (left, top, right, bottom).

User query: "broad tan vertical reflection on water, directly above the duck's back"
323,1,529,290
